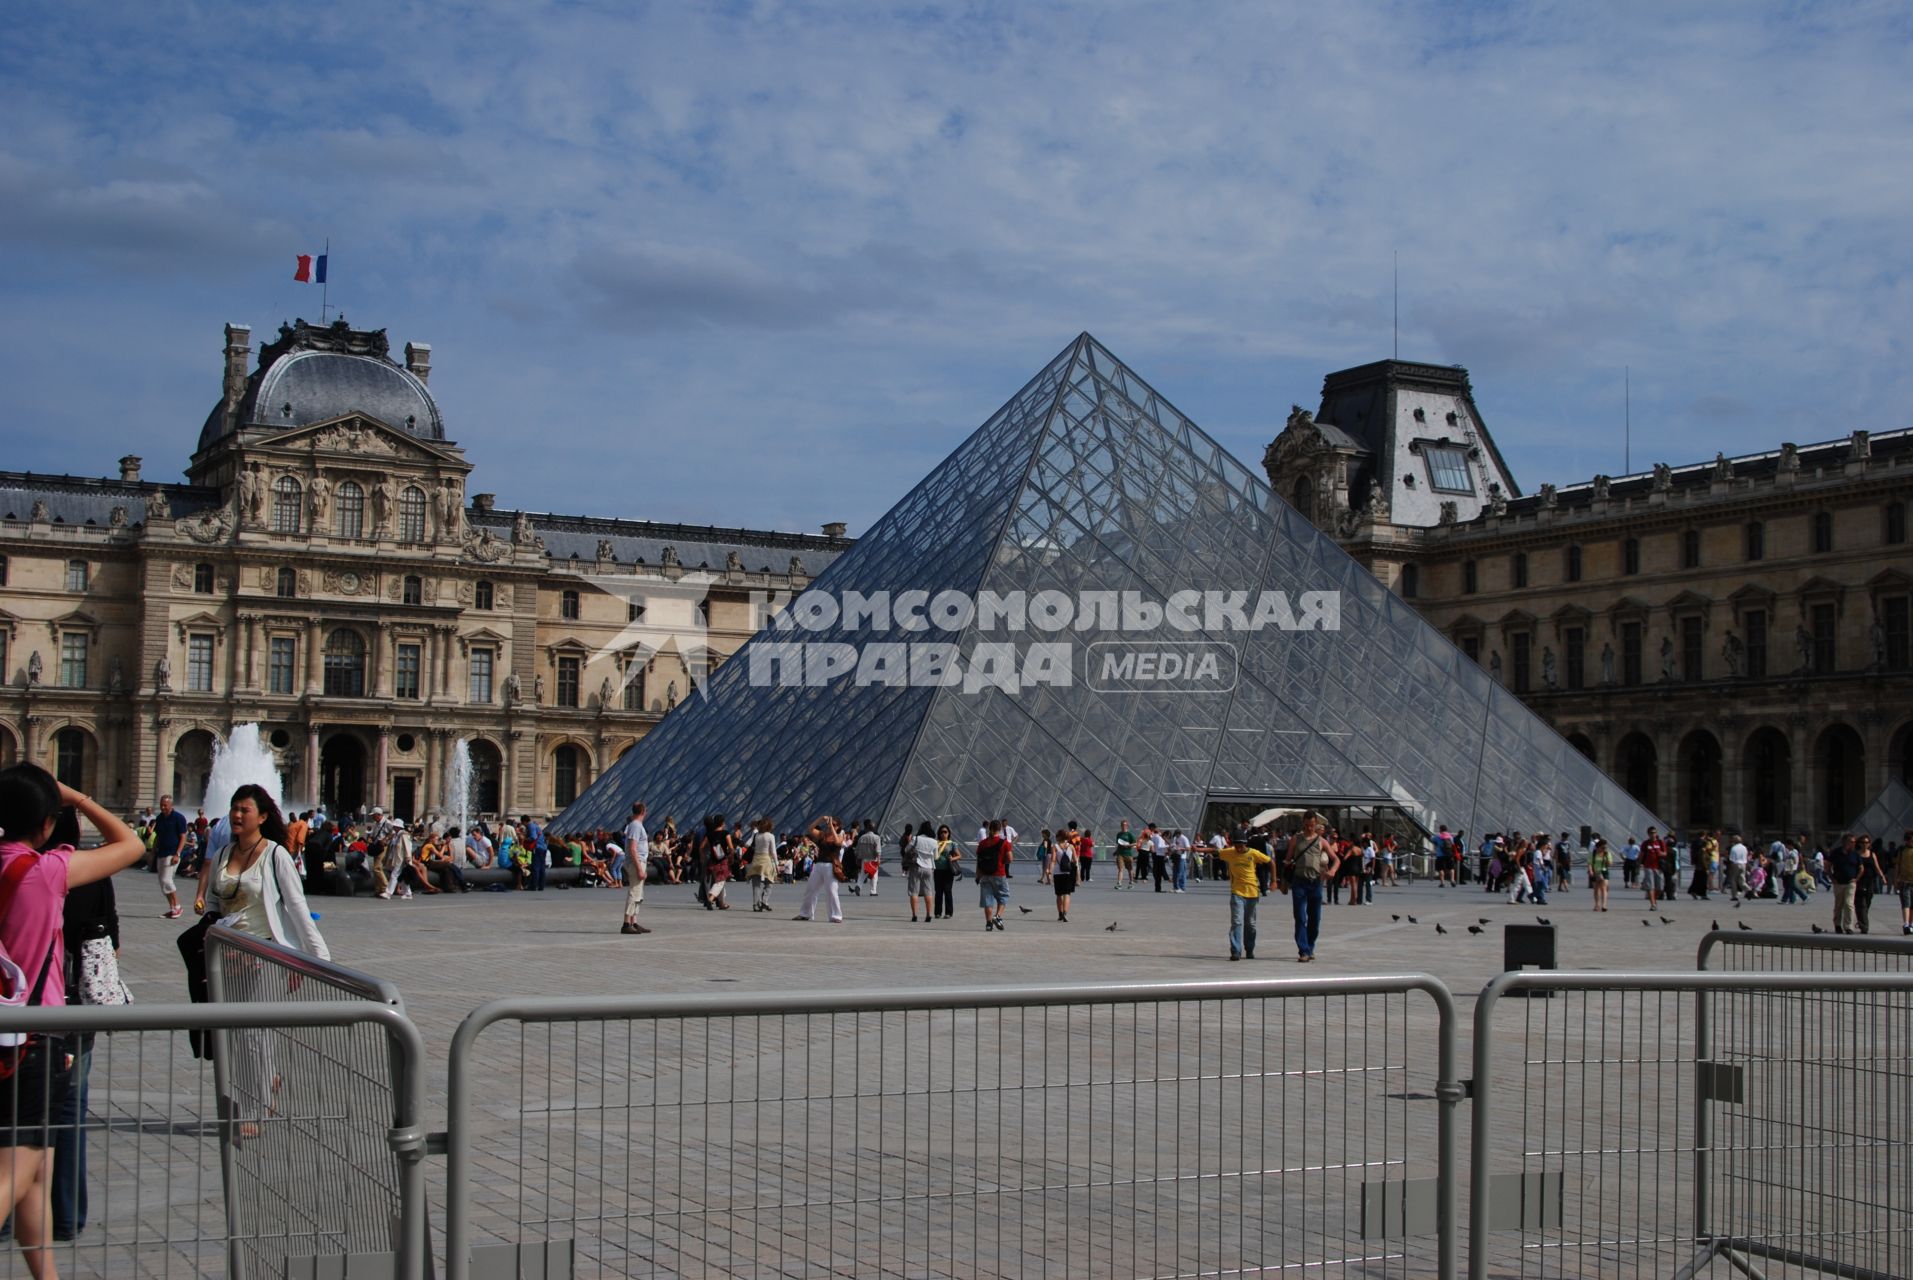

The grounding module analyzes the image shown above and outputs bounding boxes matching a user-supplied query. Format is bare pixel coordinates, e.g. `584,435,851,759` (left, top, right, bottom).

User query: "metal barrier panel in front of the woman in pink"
0,1001,425,1280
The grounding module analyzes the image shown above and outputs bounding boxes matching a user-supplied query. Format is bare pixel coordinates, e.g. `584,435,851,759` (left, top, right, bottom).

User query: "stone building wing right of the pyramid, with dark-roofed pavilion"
1264,362,1913,836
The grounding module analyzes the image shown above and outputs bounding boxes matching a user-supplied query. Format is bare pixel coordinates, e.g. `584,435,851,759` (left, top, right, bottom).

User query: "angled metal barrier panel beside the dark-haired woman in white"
207,926,425,1276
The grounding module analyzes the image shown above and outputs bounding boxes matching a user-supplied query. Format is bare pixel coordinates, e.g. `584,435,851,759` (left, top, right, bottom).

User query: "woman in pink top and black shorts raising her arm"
0,763,145,1280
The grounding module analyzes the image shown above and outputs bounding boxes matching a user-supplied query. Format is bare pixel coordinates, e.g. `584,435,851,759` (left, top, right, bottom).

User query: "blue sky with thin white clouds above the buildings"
0,0,1913,532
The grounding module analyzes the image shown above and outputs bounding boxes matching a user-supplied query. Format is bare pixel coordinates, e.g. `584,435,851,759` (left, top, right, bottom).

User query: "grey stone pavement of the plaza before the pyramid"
93,871,1884,1276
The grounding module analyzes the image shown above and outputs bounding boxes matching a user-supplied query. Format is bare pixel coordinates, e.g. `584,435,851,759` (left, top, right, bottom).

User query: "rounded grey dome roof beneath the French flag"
199,325,446,450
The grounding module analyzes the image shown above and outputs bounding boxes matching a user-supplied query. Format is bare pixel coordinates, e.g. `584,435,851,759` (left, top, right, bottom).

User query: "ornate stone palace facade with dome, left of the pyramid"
0,320,849,815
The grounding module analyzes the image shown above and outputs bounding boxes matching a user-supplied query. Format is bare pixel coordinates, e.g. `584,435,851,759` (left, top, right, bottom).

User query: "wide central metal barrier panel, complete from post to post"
446,976,1462,1280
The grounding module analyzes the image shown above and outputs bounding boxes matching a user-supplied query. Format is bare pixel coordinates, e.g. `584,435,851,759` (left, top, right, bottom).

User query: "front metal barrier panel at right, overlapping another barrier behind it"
1469,972,1913,1280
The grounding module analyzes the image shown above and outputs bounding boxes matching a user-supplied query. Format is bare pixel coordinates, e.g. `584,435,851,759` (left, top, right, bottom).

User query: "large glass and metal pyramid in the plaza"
555,333,1657,836
